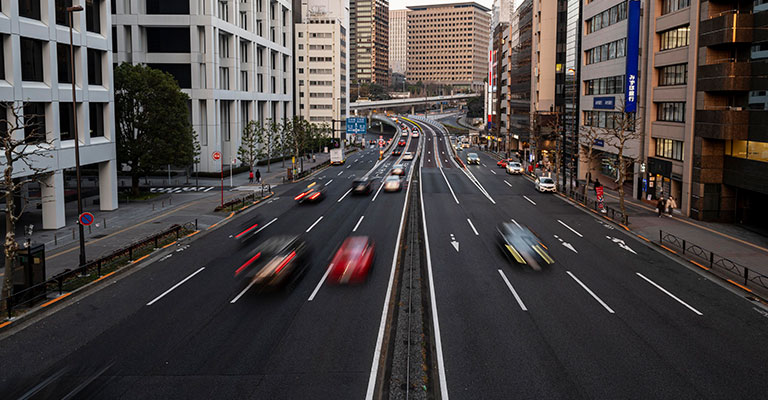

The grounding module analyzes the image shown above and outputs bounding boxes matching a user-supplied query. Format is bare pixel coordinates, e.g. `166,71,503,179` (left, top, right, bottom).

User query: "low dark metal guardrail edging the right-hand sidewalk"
659,230,768,290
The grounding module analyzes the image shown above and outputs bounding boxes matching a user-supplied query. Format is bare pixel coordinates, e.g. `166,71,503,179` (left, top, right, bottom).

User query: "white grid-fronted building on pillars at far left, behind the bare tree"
0,0,117,229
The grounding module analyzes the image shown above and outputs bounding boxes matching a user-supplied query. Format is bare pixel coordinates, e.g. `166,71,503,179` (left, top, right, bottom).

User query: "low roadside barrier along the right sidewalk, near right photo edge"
659,230,768,298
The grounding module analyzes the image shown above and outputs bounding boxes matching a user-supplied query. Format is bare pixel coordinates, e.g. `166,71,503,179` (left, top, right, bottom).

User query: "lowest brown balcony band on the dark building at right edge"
695,107,768,141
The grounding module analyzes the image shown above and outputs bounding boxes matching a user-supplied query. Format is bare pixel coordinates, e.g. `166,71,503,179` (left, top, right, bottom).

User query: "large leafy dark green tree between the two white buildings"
114,63,194,194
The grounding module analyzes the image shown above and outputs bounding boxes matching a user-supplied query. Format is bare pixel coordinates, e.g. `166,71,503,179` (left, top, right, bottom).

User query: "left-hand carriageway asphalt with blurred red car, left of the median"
0,129,418,399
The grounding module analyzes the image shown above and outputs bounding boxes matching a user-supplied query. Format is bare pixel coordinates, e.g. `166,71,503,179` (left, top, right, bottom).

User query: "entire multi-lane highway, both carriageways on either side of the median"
0,114,768,399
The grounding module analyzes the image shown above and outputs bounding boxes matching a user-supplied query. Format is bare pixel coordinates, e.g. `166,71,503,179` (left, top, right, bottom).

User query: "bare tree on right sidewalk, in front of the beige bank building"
605,101,642,219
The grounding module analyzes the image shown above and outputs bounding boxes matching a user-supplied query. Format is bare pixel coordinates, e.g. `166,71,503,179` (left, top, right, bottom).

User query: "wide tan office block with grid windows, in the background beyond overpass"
407,2,491,91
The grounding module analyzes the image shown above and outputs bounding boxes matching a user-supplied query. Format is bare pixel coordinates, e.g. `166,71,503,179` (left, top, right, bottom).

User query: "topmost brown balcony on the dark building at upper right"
699,10,754,47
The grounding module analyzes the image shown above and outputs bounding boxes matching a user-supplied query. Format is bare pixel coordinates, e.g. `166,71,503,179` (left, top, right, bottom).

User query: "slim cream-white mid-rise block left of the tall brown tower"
295,0,349,130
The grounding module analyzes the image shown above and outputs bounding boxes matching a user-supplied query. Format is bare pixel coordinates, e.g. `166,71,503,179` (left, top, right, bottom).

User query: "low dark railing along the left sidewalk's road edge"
0,219,197,319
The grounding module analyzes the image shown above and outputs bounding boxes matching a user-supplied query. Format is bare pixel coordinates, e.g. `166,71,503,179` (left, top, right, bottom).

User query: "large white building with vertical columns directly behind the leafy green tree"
113,0,293,172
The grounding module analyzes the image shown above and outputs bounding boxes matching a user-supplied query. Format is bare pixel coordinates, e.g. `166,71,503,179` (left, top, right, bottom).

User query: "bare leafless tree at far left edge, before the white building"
0,103,53,307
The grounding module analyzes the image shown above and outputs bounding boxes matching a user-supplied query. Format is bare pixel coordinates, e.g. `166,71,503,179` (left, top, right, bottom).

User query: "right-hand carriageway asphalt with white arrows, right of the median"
412,116,768,399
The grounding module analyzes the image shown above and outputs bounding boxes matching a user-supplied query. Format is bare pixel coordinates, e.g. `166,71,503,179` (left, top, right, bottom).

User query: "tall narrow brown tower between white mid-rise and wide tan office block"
349,0,389,86
